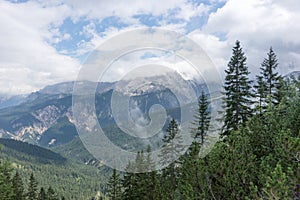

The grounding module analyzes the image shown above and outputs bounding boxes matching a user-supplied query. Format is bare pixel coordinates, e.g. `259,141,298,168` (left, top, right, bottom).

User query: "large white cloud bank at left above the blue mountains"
0,1,79,94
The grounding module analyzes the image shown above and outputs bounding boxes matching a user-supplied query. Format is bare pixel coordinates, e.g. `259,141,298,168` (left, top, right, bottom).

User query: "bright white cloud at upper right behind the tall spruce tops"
203,0,300,73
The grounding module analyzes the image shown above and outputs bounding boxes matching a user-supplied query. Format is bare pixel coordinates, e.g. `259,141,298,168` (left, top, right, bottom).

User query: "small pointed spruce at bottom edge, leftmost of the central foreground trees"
107,169,122,200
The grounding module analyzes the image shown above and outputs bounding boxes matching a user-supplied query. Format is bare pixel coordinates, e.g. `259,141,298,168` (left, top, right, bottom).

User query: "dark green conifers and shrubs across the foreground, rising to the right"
0,41,300,200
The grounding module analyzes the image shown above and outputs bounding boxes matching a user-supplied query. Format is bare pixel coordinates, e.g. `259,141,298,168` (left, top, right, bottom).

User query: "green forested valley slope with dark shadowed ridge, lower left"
0,139,105,200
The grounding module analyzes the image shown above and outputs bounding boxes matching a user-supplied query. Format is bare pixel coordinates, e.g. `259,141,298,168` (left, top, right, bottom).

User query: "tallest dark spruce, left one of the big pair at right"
222,41,253,136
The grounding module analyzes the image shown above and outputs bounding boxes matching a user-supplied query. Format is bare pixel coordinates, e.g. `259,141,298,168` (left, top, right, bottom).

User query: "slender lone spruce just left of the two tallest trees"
192,91,210,144
